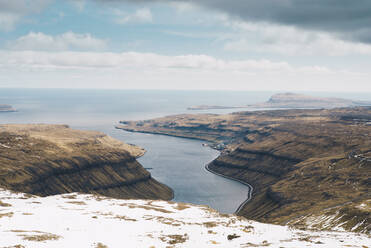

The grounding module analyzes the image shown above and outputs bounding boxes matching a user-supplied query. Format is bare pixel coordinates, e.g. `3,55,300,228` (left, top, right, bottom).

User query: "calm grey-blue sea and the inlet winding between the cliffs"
0,88,371,213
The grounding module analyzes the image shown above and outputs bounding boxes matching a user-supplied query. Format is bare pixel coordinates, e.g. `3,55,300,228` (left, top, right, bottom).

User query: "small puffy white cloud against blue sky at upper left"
8,32,106,51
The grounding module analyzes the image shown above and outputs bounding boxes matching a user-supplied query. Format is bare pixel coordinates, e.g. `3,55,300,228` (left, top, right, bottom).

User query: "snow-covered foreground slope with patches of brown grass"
0,189,371,248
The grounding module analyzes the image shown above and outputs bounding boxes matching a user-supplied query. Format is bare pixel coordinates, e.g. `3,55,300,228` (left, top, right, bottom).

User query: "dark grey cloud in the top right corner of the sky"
97,0,371,43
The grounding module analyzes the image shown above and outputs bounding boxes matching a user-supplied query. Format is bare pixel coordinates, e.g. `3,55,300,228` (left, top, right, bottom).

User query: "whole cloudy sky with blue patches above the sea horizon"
0,0,371,92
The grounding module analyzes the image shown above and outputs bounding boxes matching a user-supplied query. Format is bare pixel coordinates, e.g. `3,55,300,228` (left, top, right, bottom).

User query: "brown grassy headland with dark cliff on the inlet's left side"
0,125,172,200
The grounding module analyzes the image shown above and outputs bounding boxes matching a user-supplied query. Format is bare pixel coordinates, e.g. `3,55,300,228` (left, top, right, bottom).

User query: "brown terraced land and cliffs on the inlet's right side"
117,107,371,233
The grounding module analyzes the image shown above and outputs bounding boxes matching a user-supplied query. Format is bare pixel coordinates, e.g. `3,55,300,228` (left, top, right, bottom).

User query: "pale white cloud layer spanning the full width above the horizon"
0,50,371,91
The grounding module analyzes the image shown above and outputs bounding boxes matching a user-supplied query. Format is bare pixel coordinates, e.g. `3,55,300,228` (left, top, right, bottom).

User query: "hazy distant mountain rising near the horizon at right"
249,93,371,108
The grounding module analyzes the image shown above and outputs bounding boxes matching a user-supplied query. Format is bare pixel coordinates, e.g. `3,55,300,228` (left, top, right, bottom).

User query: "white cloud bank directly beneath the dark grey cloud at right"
224,20,371,56
